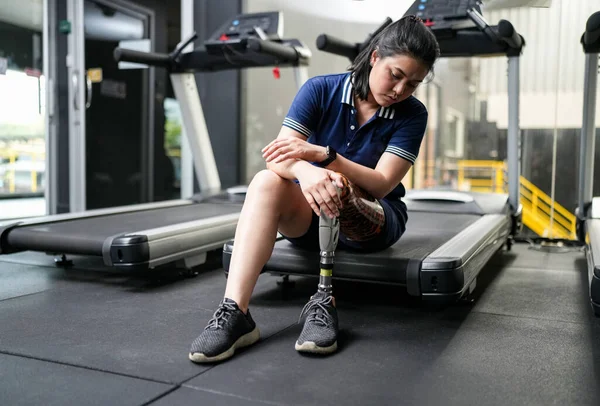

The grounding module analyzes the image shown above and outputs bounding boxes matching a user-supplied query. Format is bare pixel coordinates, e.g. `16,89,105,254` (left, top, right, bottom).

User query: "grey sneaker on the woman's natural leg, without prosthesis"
189,298,260,363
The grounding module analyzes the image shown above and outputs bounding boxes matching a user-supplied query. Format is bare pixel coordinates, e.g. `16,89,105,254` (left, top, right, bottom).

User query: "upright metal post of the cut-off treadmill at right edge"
578,53,598,219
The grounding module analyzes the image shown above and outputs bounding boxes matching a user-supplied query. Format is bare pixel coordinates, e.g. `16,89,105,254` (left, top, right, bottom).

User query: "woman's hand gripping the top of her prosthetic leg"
298,167,344,218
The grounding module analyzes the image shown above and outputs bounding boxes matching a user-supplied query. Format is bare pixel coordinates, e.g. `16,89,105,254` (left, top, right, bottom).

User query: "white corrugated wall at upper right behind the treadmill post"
477,0,600,129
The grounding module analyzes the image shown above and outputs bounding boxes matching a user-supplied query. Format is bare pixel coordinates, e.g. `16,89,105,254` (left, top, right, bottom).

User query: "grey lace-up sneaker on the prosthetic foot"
295,292,338,354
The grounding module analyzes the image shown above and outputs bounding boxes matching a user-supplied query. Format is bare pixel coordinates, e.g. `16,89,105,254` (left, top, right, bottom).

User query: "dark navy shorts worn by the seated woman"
283,200,408,252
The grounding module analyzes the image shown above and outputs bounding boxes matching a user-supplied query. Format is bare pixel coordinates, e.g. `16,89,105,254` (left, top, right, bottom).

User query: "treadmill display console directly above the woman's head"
406,0,481,29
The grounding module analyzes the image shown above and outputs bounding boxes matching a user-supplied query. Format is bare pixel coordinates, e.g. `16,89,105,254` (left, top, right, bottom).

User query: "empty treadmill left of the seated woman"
0,12,311,271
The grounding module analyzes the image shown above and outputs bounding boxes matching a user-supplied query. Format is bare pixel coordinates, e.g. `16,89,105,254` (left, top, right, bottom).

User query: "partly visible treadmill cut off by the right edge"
576,11,600,317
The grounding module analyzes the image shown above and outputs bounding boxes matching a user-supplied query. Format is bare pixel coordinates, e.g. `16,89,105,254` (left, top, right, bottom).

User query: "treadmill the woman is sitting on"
223,0,524,303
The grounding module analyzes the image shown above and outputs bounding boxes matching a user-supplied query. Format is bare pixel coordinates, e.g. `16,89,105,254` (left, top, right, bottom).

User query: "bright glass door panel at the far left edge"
0,0,50,219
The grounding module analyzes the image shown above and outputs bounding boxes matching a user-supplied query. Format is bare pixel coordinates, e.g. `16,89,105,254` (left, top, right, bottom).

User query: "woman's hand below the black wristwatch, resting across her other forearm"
262,137,327,164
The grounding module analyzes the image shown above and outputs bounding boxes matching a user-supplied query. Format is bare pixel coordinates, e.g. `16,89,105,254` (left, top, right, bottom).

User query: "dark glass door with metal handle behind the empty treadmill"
68,0,154,212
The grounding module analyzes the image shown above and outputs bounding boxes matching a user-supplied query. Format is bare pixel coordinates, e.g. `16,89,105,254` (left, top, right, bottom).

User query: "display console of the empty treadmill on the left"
204,11,283,53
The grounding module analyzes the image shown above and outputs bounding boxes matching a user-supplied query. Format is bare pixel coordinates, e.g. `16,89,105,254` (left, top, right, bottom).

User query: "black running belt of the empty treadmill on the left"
7,203,241,255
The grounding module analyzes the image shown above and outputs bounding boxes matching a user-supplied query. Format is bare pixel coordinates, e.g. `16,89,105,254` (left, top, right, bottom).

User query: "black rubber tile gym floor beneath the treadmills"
0,244,600,406
